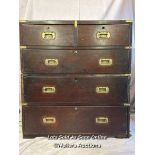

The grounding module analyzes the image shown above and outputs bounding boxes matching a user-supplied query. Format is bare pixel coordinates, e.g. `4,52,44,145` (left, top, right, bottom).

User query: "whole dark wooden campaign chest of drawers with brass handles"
20,20,132,138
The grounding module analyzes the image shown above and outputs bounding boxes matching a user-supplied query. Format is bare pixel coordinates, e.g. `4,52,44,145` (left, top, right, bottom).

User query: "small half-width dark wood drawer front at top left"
20,24,74,46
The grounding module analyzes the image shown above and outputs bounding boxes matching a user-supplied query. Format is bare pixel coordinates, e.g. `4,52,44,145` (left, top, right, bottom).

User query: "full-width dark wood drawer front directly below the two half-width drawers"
21,49,131,74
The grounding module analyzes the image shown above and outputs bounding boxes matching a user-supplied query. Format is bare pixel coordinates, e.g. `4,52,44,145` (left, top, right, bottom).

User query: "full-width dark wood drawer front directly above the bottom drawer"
24,75,129,105
